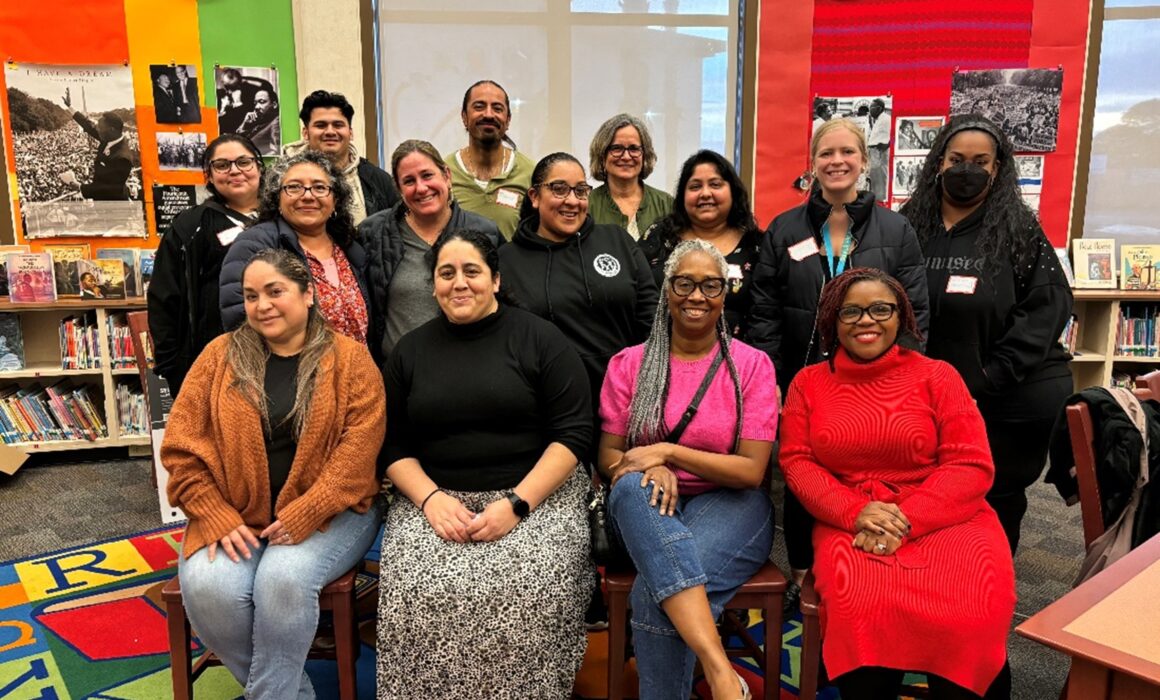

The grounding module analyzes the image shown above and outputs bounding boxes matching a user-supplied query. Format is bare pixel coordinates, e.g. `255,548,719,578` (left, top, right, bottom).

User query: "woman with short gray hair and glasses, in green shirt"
588,114,673,239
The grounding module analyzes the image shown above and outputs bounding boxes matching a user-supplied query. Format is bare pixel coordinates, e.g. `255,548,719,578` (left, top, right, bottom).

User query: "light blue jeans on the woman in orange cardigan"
177,504,382,700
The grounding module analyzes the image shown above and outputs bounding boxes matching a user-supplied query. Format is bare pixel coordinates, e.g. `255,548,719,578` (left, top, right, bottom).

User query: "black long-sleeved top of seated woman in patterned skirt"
379,304,593,491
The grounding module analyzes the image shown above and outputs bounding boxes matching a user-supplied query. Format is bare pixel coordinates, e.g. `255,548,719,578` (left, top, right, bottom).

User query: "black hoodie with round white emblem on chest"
500,216,657,405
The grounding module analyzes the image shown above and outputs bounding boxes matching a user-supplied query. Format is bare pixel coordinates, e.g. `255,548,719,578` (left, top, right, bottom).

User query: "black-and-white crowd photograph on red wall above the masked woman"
950,68,1064,153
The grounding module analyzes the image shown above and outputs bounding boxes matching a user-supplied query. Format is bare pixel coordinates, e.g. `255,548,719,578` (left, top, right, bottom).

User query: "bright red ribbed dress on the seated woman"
780,346,1015,695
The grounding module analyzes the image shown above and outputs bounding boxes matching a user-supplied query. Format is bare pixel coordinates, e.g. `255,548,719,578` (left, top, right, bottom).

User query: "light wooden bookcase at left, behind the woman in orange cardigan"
0,297,150,454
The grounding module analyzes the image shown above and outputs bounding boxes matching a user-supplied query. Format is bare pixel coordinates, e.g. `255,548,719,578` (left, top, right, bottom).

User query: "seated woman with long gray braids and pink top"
600,240,777,700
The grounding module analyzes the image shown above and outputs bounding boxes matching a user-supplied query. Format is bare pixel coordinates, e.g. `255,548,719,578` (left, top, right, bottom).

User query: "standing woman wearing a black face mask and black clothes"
901,114,1072,554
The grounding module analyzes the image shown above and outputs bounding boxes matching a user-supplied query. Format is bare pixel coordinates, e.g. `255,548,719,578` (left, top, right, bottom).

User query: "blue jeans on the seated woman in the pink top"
608,474,774,700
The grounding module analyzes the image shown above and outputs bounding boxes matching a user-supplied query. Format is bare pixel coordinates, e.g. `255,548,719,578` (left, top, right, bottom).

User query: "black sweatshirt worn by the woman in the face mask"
926,207,1072,412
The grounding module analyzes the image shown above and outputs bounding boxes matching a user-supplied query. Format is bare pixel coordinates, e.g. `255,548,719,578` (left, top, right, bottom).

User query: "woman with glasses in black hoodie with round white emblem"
500,153,657,443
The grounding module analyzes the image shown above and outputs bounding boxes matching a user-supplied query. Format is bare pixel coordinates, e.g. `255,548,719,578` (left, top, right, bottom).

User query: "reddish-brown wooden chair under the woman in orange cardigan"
161,568,360,700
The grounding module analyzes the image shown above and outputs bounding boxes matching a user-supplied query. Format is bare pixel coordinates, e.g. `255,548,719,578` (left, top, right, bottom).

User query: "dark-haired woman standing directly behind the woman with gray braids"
640,151,762,340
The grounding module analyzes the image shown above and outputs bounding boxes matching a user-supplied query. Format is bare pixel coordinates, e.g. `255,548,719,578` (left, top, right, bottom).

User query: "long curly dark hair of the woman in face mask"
900,114,1039,269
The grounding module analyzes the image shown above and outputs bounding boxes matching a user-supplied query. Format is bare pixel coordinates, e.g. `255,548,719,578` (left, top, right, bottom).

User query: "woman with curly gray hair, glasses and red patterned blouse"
220,151,382,361
